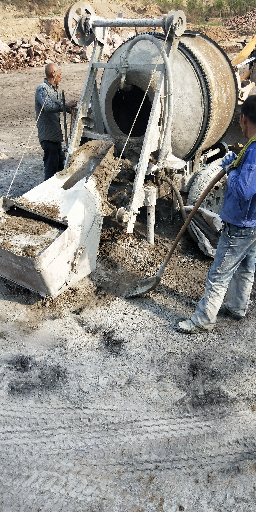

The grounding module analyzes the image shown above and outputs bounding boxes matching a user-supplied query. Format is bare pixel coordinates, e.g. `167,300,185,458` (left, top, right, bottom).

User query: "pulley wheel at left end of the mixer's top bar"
64,2,95,46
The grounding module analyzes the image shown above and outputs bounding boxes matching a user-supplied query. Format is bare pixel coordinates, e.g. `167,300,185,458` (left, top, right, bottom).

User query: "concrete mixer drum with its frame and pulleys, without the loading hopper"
65,2,238,235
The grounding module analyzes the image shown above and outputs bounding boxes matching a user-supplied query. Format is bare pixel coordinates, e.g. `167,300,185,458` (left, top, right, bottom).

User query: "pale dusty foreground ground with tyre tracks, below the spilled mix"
1,283,256,512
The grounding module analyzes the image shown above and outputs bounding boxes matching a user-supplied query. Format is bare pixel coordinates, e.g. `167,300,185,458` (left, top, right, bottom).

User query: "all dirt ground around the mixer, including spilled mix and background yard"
0,2,256,512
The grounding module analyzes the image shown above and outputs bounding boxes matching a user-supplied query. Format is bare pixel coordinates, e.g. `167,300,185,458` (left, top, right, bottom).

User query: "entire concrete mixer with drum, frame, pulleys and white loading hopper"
0,2,240,296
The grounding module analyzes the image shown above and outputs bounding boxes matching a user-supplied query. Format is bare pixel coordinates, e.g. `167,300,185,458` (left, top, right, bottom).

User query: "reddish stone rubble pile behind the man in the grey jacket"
0,30,134,73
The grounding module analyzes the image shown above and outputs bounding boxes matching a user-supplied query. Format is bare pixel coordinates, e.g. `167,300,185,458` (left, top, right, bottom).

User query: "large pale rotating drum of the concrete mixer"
100,31,237,159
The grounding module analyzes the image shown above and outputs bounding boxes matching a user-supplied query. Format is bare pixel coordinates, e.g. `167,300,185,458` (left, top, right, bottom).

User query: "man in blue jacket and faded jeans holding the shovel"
178,95,256,333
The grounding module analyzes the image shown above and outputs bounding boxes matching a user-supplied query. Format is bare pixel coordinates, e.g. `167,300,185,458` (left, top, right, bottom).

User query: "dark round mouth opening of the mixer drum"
112,85,151,137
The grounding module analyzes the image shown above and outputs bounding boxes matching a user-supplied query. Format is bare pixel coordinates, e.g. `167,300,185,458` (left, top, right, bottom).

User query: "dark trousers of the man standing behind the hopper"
40,140,65,181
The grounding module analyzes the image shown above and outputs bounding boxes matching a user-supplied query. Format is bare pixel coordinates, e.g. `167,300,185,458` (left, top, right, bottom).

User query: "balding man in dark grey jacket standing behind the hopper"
35,63,77,180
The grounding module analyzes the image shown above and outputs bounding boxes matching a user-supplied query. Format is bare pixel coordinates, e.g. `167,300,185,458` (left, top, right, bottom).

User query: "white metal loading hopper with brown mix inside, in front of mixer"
0,141,114,297
